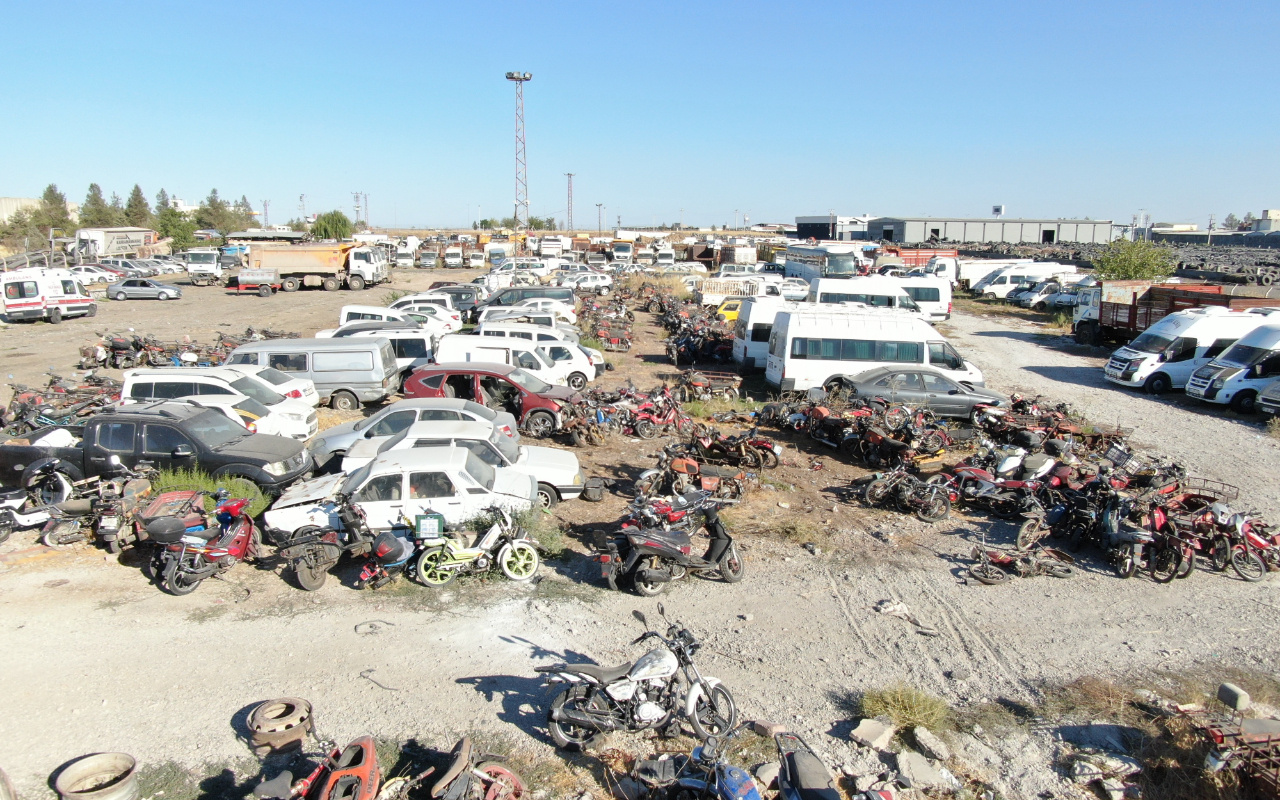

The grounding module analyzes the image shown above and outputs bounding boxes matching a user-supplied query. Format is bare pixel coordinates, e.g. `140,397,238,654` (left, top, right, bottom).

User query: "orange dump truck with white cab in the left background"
244,242,390,292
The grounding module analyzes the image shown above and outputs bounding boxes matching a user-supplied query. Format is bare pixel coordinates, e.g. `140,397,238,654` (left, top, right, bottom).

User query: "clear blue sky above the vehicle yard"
0,0,1280,228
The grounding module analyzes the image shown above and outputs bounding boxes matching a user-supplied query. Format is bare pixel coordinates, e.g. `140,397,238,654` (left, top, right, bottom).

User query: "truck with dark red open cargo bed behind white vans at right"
1071,280,1280,344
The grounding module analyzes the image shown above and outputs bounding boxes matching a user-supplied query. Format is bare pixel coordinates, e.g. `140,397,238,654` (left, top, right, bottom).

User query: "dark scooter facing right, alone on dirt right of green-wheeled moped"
595,493,746,596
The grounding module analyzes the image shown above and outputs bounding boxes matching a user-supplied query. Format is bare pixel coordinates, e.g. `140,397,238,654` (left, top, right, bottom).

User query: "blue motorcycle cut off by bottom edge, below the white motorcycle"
631,723,760,800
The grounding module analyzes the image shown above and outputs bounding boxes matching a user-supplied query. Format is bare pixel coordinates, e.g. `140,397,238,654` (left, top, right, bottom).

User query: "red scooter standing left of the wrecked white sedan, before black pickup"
147,489,262,595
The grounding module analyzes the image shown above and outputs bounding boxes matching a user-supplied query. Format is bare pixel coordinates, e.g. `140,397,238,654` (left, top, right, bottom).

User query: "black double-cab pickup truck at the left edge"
0,403,312,495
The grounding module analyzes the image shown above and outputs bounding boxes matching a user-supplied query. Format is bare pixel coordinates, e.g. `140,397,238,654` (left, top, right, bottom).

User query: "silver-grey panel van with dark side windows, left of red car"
227,337,399,411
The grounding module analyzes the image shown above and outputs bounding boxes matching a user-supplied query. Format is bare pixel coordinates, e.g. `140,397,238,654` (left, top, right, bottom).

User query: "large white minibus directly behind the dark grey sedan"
764,311,983,392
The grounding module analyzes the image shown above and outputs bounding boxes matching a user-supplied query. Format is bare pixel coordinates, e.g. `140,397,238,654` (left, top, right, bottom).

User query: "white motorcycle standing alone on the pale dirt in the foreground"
535,603,737,750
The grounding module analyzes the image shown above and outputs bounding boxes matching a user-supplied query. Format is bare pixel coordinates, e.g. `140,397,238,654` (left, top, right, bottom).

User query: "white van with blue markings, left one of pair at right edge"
1103,306,1280,394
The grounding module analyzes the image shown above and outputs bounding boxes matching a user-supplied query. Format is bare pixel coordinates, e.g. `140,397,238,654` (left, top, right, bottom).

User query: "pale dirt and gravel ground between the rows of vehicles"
0,271,1280,797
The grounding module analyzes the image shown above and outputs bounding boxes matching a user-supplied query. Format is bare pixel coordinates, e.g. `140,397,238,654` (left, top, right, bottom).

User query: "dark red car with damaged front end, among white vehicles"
404,361,575,436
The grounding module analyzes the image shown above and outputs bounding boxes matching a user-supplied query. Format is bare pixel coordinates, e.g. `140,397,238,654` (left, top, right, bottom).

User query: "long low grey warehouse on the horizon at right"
865,216,1114,244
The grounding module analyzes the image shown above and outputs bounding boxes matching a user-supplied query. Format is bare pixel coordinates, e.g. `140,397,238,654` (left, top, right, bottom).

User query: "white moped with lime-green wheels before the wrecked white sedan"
417,507,541,589
